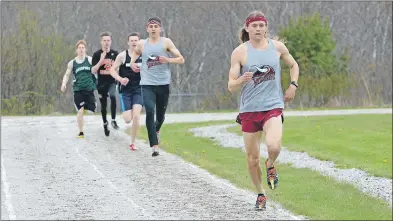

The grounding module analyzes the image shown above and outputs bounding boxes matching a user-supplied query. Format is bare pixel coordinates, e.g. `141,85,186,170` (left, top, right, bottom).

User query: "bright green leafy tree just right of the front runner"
279,13,350,107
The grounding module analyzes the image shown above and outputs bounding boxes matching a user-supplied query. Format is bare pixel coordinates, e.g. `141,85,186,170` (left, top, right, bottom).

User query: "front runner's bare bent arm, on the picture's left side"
228,47,242,93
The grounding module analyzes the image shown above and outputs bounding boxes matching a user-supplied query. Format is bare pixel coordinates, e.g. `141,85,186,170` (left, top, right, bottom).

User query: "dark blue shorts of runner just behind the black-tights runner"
119,86,143,112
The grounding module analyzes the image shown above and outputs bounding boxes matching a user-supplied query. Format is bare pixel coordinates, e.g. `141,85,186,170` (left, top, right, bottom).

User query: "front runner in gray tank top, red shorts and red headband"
228,11,299,209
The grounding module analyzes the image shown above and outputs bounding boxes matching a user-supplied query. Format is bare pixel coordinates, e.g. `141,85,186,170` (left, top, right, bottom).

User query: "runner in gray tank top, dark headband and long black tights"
130,18,184,157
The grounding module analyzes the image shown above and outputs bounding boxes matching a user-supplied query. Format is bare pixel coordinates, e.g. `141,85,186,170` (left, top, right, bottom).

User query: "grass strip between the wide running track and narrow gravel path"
130,121,392,220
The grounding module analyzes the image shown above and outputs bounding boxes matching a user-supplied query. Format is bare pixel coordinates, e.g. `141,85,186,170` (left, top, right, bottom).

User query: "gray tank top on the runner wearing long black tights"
140,37,171,85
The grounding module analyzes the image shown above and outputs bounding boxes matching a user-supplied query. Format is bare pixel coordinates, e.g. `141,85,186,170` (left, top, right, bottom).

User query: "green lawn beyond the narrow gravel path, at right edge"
228,114,392,178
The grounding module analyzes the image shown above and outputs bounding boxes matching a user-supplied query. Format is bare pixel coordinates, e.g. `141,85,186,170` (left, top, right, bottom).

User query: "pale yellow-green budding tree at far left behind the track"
1,7,74,114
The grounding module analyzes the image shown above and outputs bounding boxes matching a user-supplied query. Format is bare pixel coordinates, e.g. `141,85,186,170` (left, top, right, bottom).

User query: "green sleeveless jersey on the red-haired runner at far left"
72,57,96,91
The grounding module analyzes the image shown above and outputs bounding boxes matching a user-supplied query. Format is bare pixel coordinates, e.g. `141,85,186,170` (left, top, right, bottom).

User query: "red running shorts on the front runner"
236,108,284,133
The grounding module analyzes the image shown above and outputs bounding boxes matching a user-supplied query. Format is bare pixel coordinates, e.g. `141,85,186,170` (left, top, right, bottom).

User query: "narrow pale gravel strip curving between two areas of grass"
191,124,393,207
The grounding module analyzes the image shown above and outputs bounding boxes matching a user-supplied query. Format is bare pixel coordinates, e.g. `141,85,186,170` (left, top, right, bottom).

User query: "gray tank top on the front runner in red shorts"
240,39,284,113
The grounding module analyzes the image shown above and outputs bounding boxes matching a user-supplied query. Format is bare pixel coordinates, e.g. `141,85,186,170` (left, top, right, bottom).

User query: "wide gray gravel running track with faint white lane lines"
1,116,302,220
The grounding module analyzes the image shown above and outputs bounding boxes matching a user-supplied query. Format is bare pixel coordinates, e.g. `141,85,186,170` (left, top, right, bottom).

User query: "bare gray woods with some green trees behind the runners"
1,1,392,115
